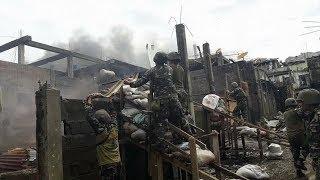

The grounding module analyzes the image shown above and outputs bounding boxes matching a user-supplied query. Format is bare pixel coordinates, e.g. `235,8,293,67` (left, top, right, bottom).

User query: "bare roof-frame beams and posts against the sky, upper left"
0,36,105,78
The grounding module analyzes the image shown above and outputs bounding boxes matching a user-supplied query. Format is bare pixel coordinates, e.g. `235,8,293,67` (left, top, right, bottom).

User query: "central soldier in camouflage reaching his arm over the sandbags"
125,52,190,144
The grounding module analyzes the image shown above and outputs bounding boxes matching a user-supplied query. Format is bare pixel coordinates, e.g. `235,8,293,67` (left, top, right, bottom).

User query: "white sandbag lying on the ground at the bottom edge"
236,164,270,179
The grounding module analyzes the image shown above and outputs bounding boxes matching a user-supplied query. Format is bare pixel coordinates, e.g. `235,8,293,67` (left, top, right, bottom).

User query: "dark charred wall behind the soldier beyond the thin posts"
190,61,276,122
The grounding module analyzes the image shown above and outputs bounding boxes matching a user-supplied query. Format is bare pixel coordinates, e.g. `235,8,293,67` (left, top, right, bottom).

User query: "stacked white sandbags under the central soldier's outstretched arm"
123,85,150,108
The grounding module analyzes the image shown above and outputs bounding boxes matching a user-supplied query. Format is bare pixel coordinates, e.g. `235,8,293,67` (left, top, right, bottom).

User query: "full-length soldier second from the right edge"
284,98,309,177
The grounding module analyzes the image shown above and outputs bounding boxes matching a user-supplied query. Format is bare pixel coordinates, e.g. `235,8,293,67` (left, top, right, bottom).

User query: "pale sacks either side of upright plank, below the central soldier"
178,142,215,166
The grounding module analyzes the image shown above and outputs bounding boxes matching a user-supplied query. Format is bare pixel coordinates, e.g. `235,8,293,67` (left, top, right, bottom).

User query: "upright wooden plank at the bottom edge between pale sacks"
189,137,199,180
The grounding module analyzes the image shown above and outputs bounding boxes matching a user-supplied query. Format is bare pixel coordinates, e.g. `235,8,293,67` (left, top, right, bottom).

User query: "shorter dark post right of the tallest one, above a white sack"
202,43,215,94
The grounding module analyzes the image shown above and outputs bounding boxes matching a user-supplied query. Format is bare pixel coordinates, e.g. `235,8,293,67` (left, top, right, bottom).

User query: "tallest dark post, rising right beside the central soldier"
176,24,195,118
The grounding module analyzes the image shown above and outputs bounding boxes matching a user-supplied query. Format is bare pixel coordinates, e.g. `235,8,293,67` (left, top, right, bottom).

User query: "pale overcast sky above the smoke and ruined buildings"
0,0,320,67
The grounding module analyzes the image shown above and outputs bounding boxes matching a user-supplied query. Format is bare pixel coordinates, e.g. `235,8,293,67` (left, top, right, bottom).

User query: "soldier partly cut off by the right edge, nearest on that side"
297,89,320,180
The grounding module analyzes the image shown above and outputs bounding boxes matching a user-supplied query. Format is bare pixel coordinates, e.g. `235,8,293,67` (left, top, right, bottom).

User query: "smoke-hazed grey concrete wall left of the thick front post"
0,61,50,150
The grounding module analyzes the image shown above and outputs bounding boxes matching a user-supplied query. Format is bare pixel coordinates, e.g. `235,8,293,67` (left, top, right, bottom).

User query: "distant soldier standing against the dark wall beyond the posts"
229,82,248,119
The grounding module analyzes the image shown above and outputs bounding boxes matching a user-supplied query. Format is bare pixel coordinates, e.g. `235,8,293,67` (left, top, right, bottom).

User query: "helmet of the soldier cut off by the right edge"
297,89,320,105
